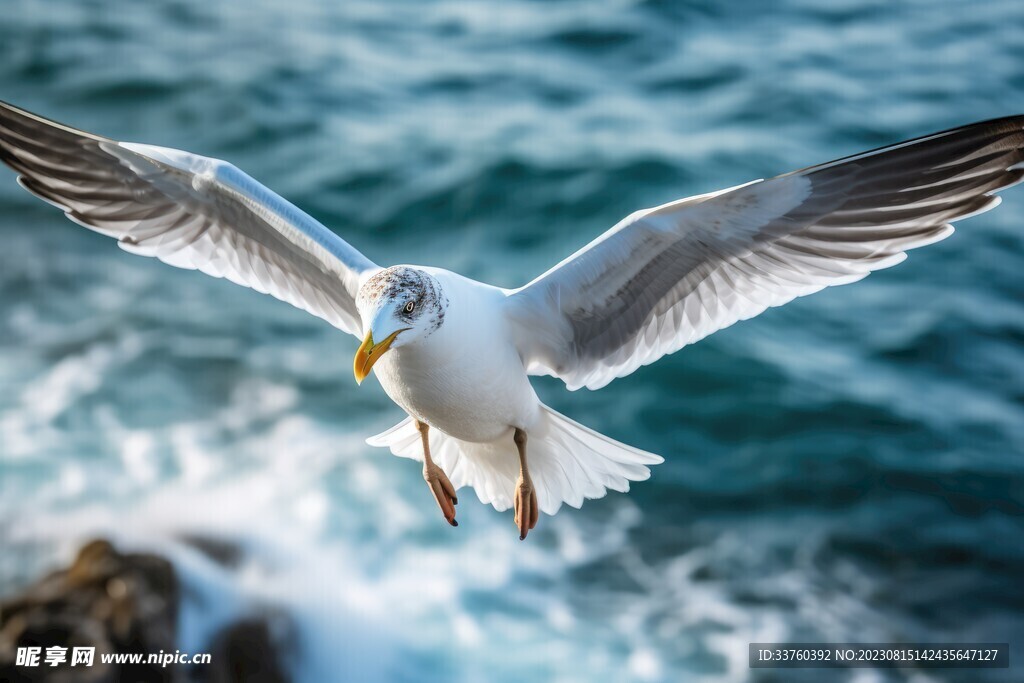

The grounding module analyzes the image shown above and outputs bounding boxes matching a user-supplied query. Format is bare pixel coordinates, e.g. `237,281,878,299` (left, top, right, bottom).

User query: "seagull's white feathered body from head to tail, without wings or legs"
358,266,662,514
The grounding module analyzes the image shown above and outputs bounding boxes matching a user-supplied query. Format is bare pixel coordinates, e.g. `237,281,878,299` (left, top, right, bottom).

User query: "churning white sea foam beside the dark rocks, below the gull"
2,354,929,683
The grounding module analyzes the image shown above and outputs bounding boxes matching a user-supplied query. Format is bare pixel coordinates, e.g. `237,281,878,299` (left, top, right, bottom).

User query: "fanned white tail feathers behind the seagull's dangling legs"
367,405,664,515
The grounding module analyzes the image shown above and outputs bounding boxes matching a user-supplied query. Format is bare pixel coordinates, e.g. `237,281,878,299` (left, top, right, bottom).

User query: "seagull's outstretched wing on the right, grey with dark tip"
508,116,1024,389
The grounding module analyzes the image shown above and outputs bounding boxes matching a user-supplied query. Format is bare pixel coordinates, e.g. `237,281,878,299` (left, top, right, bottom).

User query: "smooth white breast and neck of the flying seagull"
374,268,541,442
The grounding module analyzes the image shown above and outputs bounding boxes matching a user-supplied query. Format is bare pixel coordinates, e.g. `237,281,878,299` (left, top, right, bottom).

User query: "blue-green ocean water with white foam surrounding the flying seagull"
0,0,1024,683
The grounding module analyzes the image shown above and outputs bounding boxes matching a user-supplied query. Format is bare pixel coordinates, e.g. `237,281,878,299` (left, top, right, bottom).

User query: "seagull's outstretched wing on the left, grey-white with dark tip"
0,102,378,336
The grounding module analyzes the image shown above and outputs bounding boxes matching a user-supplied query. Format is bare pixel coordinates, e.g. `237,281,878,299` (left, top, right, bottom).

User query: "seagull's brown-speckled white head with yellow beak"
352,265,447,384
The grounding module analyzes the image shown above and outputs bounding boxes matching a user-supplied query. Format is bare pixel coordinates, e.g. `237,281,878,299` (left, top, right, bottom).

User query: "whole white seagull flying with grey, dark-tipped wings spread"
0,102,1024,539
